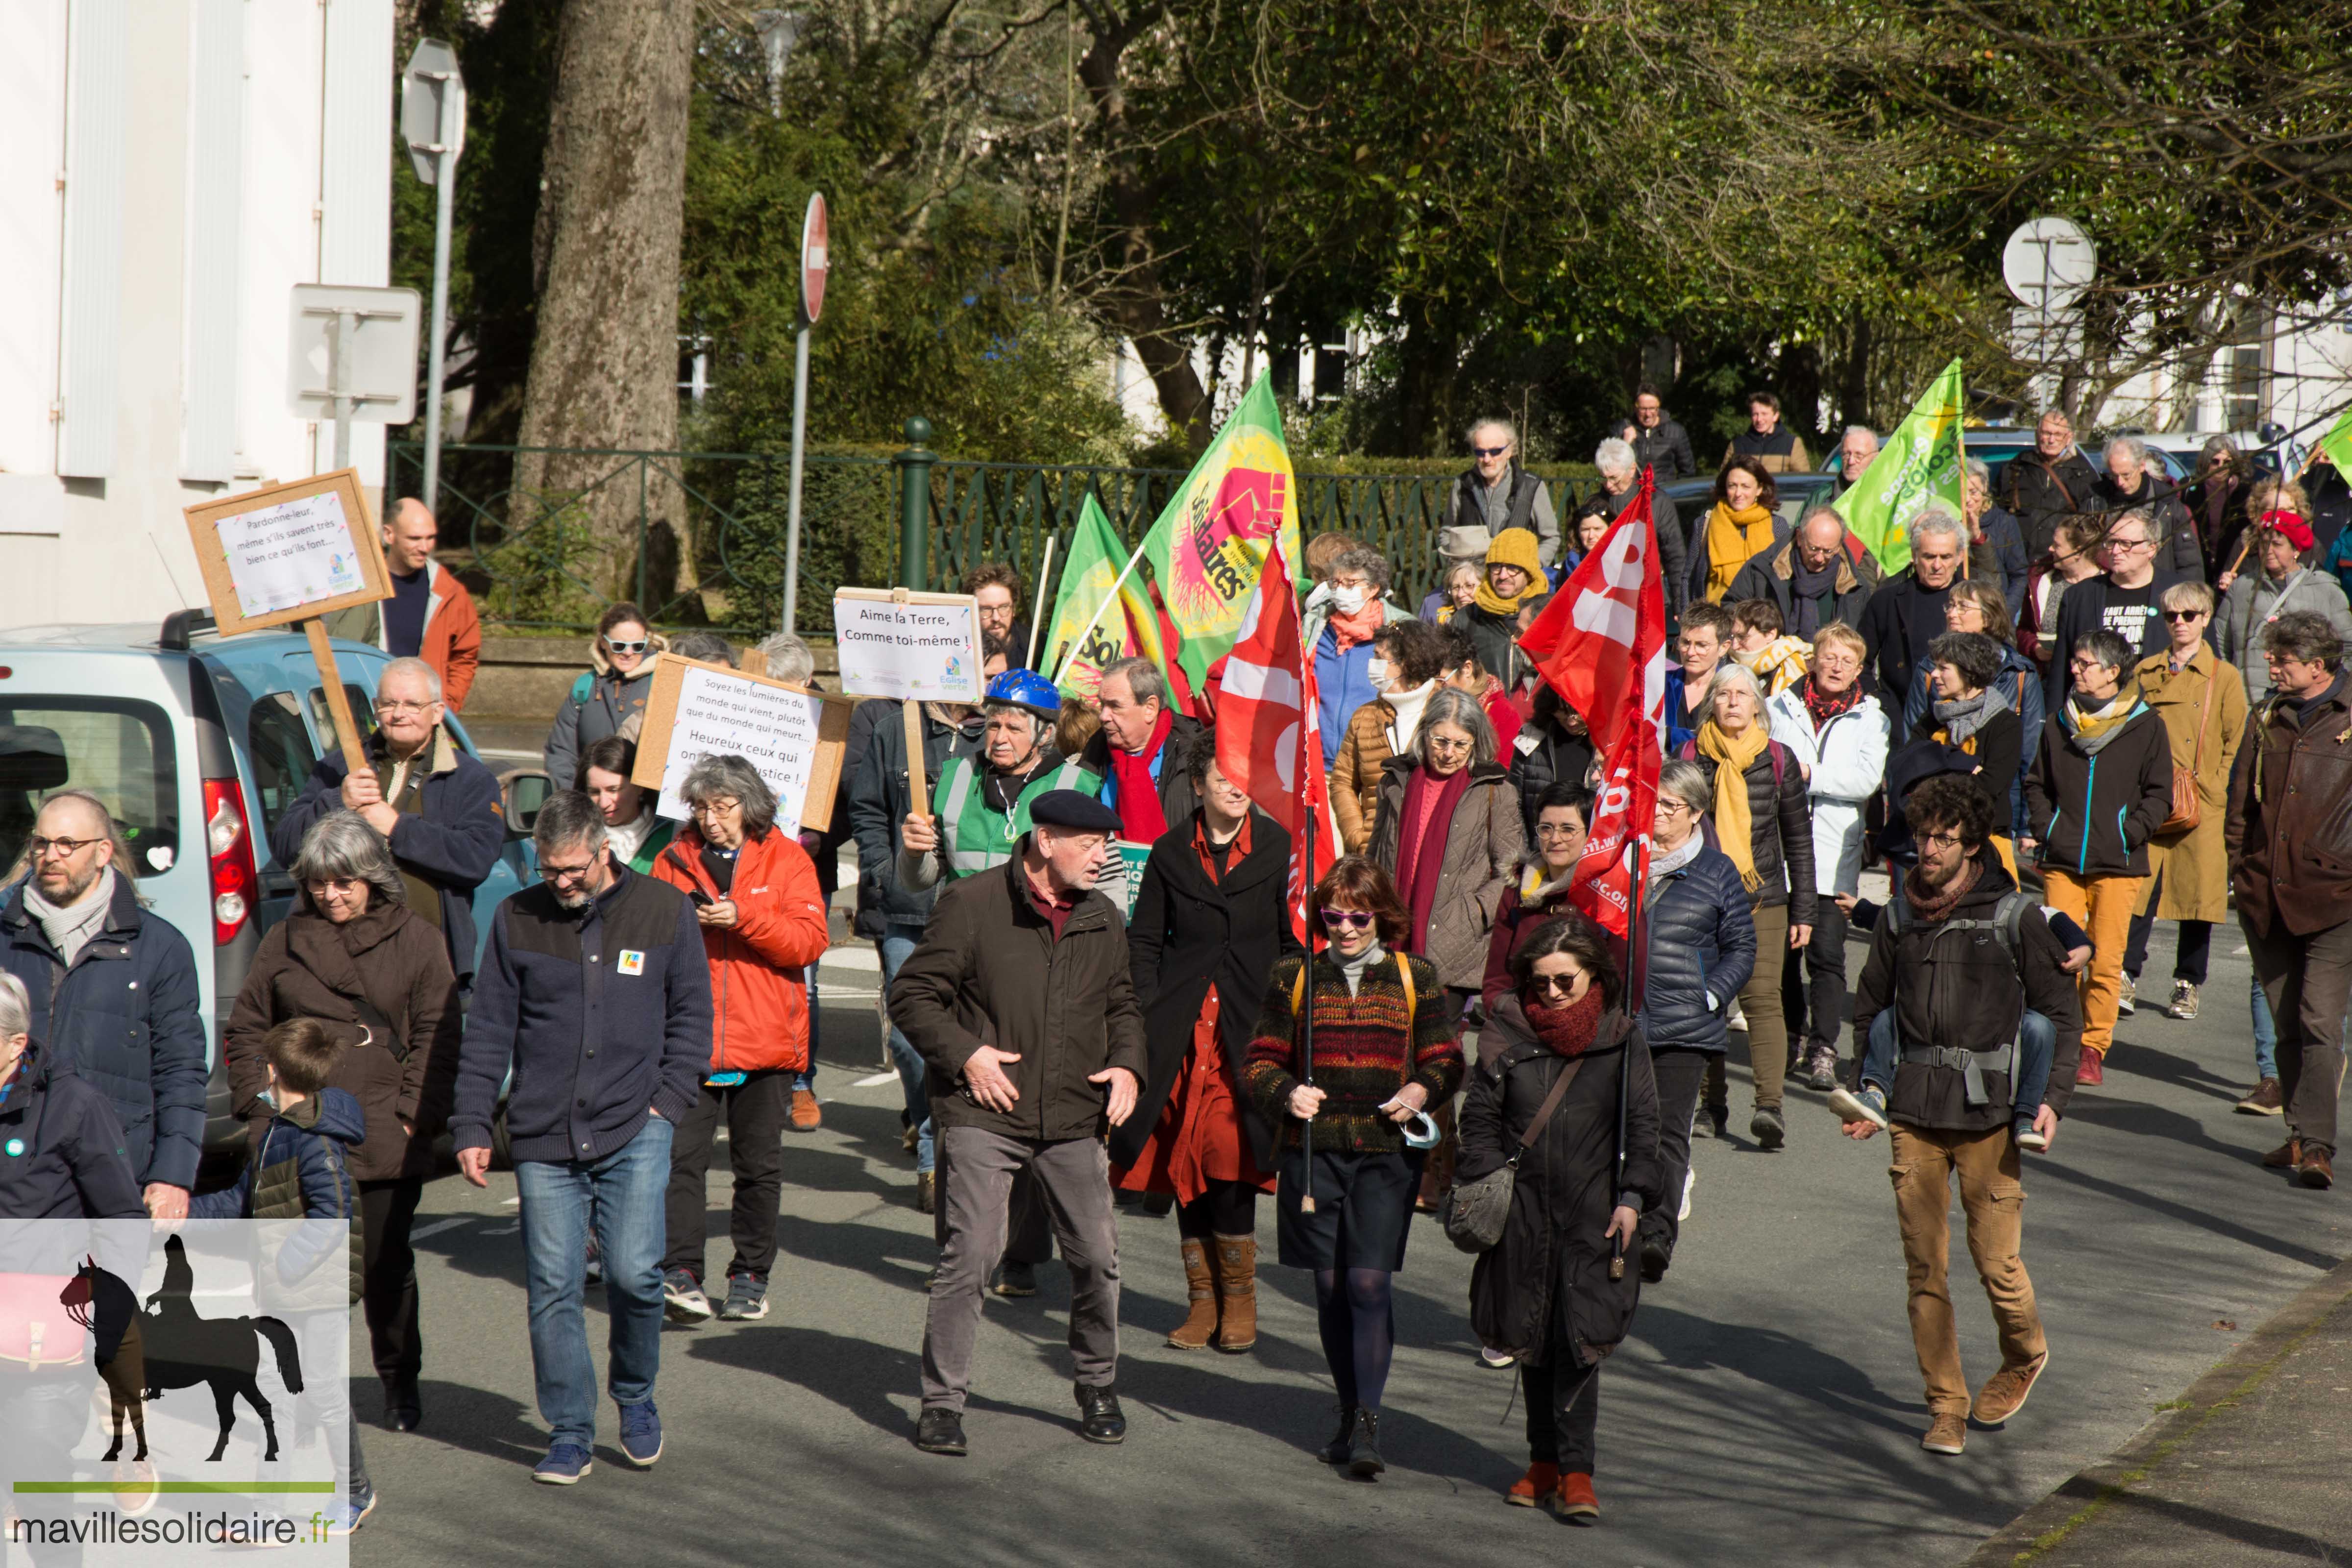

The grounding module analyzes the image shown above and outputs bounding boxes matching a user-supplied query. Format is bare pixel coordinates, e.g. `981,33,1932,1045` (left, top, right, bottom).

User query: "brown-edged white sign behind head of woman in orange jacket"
630,654,852,830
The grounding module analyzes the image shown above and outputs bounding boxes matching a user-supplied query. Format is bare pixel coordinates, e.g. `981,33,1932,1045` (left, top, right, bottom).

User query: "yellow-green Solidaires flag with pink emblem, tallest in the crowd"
1143,376,1305,689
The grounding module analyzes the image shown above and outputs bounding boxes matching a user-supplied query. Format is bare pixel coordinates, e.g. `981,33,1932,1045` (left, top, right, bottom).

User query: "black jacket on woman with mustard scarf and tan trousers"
2025,691,2173,877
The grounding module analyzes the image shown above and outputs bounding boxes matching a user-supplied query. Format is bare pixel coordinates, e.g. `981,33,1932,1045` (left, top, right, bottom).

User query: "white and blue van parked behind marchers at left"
0,611,546,1147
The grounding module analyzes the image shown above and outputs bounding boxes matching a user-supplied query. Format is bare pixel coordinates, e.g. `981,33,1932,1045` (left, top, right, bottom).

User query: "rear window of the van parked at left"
0,693,179,877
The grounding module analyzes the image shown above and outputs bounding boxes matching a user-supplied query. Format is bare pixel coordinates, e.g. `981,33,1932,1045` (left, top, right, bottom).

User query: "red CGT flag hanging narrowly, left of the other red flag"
1216,543,1338,943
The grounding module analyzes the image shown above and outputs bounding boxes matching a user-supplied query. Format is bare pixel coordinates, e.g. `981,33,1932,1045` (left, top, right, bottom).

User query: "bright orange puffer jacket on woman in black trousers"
654,825,833,1072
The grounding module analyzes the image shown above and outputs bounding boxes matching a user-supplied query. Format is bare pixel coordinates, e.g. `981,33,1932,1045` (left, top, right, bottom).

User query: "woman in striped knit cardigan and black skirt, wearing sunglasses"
1244,856,1463,1479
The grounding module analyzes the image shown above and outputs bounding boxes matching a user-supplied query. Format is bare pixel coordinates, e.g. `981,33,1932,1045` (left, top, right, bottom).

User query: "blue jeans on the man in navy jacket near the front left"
515,1117,675,1448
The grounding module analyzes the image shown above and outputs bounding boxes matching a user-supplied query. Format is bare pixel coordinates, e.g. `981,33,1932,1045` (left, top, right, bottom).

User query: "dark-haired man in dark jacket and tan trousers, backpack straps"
1832,773,2082,1453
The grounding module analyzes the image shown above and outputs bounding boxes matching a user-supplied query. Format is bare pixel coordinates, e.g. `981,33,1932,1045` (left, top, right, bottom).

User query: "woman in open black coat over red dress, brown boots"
1110,731,1298,1354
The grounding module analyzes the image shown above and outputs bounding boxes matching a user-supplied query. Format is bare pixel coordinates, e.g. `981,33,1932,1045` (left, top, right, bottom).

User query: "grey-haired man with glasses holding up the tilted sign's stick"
270,658,506,985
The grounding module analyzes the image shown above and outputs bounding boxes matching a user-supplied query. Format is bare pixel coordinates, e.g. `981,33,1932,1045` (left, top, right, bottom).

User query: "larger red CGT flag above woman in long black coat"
1519,468,1665,935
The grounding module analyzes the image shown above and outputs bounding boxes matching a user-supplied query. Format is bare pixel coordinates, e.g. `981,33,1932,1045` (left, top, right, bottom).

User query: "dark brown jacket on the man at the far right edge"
2228,672,2352,935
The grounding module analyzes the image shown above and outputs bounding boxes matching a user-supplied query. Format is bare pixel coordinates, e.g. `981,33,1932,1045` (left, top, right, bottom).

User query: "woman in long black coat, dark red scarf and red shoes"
1458,919,1663,1523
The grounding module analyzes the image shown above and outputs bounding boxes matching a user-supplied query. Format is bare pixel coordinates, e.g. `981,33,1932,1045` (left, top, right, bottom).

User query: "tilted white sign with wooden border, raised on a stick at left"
186,468,393,637
